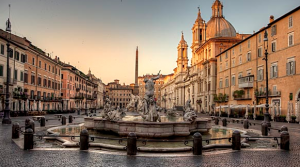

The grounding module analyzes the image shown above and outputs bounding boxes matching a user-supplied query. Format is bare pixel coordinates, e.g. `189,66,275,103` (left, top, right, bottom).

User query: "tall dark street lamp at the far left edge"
2,19,12,124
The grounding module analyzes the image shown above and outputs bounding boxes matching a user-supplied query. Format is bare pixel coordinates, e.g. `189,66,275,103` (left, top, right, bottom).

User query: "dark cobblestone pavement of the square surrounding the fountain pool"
0,111,300,167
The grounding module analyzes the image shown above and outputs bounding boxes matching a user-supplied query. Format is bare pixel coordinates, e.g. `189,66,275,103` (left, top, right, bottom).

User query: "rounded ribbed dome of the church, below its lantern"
206,17,236,39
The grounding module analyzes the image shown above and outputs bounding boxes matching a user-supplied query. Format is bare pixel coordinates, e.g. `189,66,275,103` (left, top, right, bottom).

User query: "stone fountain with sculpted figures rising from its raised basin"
84,73,211,138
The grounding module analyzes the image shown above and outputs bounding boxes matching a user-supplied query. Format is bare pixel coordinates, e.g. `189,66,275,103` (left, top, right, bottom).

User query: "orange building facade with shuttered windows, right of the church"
215,7,300,116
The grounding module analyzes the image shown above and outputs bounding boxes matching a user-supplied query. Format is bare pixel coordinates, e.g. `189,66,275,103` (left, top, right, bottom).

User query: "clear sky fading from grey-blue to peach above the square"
0,0,300,84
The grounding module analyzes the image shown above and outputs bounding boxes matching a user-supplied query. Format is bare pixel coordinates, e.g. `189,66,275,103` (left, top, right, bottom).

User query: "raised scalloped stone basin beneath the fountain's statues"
84,116,211,138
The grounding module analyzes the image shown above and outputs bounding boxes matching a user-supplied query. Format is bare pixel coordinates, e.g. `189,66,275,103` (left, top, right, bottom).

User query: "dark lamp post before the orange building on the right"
263,30,271,127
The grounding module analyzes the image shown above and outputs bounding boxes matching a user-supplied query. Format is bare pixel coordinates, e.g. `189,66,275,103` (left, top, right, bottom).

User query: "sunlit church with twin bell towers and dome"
161,0,250,112
